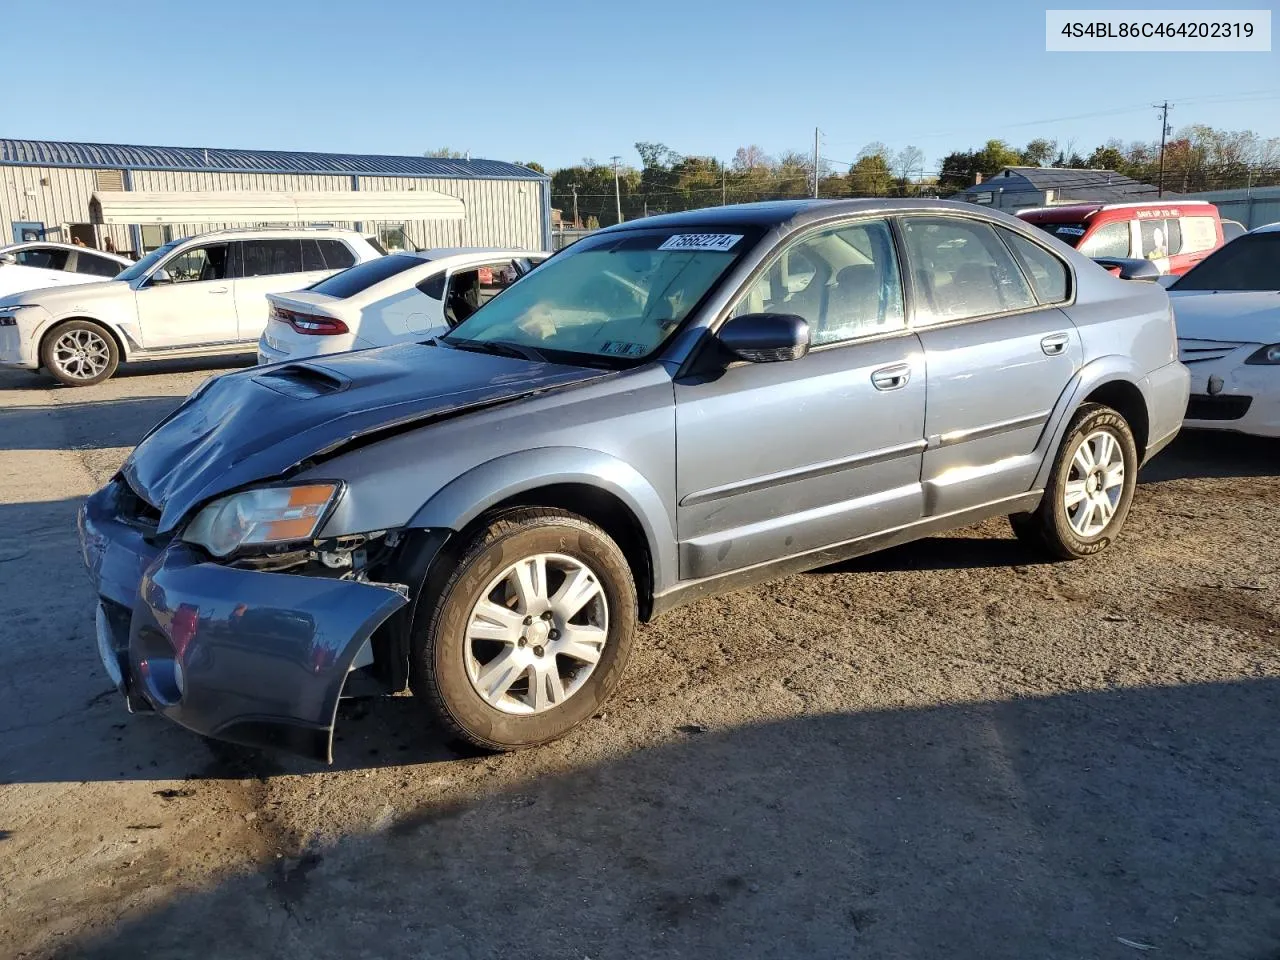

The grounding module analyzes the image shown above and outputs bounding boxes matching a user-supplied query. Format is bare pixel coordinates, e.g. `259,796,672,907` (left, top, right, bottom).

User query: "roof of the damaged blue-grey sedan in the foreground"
591,197,1016,236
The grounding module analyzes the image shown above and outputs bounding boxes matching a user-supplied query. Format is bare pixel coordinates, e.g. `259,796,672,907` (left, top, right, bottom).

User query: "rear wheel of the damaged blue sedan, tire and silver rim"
1009,403,1138,559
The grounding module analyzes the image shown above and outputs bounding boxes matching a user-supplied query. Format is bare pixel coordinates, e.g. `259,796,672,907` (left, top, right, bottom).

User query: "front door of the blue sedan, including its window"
676,219,925,580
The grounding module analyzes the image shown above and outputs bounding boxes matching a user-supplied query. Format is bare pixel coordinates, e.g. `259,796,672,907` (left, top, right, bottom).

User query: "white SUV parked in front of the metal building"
0,229,381,387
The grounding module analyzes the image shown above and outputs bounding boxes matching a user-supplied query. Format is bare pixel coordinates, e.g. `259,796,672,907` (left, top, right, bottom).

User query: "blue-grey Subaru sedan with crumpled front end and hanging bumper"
79,200,1188,759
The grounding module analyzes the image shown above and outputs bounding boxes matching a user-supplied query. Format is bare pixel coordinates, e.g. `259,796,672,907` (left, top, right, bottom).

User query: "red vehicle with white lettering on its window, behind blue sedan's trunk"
1018,200,1224,275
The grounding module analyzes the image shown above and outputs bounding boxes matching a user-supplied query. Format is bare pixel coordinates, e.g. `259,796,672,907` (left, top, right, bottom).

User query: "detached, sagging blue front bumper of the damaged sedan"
79,480,406,762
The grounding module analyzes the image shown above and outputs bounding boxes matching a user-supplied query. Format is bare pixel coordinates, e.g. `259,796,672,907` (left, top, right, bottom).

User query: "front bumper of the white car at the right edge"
1183,358,1280,436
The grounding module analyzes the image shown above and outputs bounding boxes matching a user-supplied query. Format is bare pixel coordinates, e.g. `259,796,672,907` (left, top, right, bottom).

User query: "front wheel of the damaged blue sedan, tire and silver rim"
410,507,637,750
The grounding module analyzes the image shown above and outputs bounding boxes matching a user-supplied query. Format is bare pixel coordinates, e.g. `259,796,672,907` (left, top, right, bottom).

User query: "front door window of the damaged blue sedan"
732,220,906,346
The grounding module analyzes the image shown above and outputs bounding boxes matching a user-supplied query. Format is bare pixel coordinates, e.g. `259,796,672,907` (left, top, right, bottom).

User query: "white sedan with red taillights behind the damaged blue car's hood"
257,248,550,364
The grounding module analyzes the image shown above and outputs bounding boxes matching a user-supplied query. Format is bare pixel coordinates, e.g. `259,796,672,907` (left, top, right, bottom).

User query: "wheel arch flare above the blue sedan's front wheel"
408,447,678,593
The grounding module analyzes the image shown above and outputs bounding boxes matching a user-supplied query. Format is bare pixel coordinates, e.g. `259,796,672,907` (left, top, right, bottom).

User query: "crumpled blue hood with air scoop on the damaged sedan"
123,343,609,532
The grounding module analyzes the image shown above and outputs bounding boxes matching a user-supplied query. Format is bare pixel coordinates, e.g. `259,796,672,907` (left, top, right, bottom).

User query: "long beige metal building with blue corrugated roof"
0,138,552,256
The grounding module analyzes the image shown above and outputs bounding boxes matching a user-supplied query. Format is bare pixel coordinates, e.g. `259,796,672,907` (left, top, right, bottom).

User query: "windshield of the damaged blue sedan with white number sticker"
443,229,754,366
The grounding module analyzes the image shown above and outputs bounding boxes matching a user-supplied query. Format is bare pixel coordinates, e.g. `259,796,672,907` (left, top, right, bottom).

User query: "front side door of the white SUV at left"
134,243,237,351
